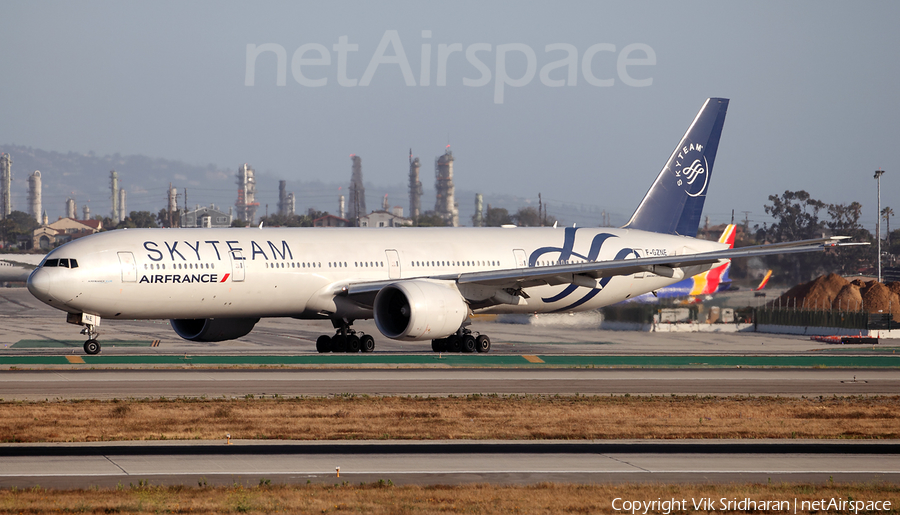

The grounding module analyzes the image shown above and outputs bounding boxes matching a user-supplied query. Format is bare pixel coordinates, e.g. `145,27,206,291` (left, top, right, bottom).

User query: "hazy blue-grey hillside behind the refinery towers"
0,145,626,226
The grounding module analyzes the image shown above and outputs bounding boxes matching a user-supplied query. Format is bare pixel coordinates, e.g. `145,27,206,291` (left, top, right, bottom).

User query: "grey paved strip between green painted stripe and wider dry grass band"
0,368,900,401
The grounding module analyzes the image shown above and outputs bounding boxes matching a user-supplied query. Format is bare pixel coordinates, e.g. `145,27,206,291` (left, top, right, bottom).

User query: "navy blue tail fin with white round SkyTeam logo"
625,98,728,237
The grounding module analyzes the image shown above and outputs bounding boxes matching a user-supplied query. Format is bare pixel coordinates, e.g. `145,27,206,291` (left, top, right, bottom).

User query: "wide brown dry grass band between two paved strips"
0,395,900,442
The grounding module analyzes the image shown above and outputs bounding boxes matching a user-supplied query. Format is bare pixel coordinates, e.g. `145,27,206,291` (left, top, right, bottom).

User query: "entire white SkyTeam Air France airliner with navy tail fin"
28,98,852,354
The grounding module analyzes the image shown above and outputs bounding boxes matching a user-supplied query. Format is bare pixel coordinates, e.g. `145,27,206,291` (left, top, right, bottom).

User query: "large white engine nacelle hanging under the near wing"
372,279,469,341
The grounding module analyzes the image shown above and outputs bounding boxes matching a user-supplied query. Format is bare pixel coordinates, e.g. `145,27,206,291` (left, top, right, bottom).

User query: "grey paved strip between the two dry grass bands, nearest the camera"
0,440,900,488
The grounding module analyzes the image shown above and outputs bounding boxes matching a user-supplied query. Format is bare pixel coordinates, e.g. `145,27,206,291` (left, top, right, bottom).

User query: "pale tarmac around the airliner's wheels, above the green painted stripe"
0,288,900,357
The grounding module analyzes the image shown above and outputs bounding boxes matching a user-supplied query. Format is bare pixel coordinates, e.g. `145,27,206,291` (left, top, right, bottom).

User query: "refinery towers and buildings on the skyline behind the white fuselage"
0,145,484,245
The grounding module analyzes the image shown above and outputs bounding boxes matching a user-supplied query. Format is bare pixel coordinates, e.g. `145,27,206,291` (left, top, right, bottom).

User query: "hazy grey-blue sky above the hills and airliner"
0,1,900,229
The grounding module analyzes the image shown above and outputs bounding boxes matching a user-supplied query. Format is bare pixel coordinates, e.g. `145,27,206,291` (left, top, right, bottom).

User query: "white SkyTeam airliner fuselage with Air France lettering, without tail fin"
31,228,727,319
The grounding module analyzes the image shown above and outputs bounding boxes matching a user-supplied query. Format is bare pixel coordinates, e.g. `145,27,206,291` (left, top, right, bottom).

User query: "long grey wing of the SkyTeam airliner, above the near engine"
334,236,865,304
